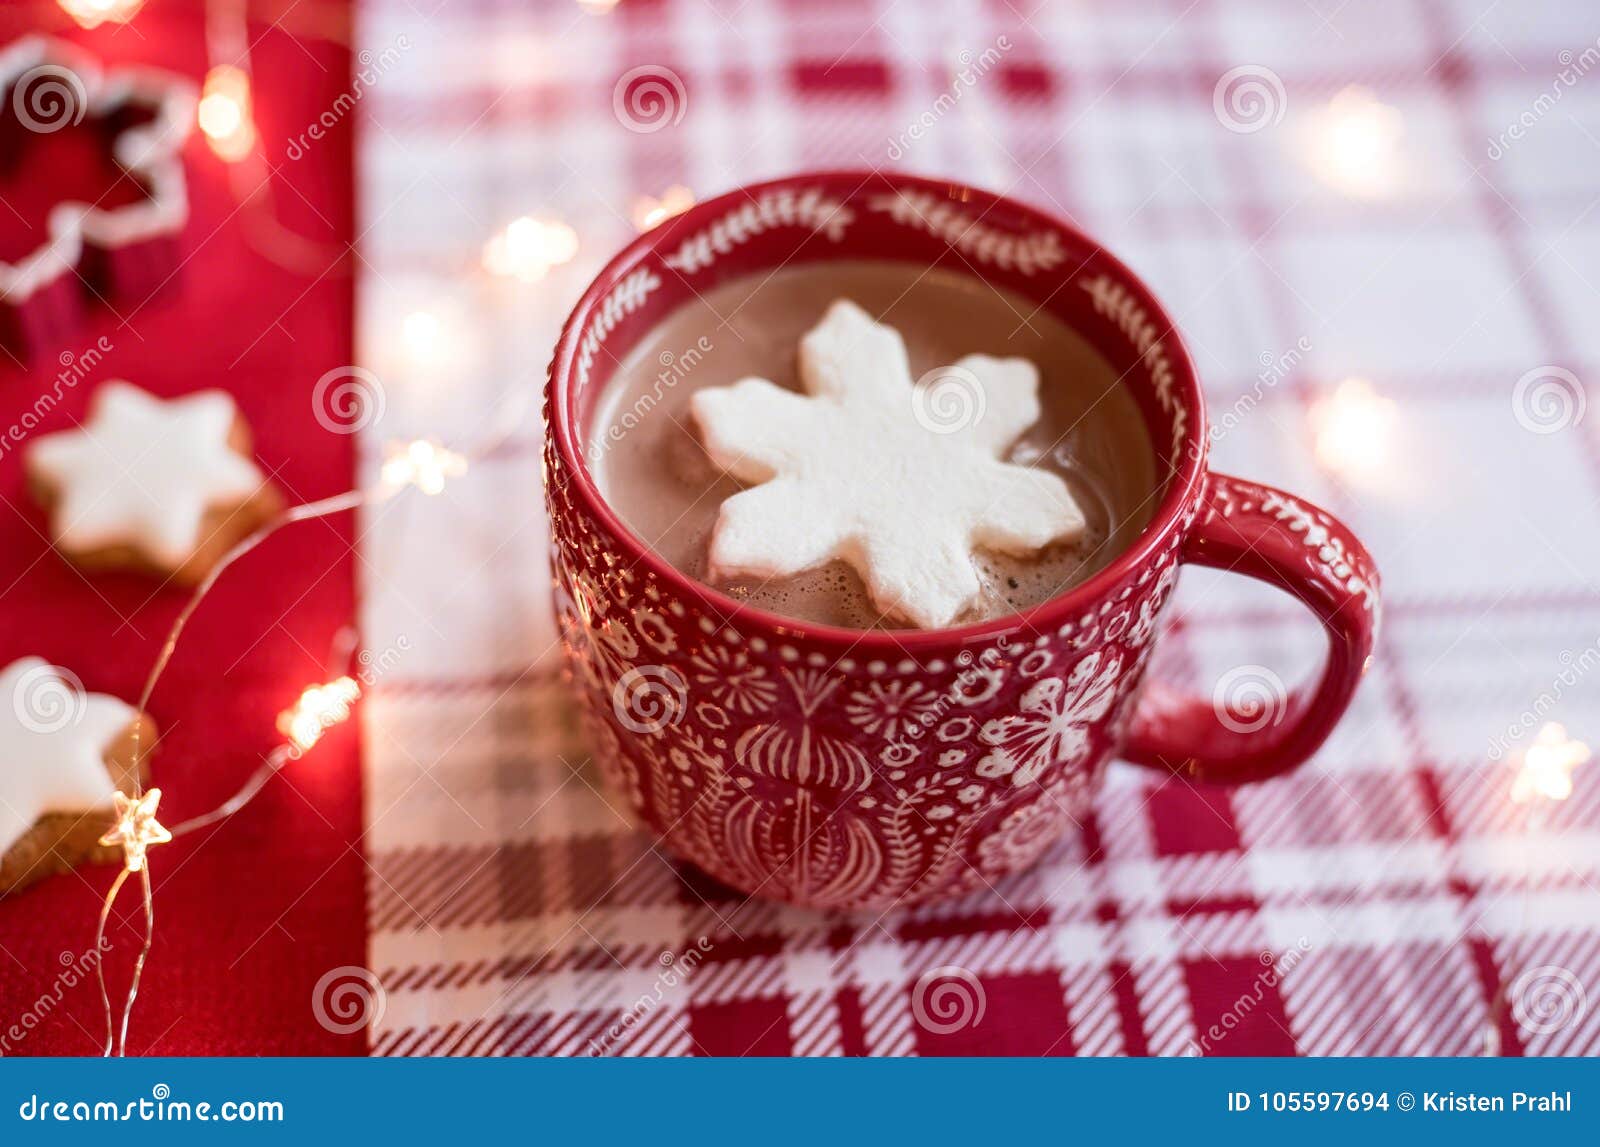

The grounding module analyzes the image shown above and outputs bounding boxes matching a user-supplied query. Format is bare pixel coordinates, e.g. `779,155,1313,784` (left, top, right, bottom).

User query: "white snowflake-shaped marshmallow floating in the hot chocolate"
691,299,1085,629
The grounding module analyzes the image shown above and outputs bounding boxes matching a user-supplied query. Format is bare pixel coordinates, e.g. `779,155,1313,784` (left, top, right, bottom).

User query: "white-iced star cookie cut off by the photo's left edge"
0,657,155,896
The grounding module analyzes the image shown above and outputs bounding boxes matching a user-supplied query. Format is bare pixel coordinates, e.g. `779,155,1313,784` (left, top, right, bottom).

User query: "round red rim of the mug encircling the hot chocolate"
546,168,1210,656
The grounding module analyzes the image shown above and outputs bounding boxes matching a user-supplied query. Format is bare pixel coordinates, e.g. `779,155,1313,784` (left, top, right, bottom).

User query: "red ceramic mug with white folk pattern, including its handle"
544,173,1378,909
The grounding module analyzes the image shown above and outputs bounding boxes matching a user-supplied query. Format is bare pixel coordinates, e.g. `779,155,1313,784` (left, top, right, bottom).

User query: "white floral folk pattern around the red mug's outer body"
537,505,1176,907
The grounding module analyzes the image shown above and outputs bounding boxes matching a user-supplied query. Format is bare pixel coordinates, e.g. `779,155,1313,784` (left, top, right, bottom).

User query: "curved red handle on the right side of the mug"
1123,472,1379,784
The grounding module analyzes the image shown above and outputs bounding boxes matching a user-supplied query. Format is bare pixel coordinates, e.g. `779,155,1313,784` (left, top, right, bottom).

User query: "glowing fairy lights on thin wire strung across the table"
34,0,1590,1056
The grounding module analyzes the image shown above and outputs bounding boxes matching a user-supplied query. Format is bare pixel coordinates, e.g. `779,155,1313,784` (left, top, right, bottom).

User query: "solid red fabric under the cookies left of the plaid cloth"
0,0,365,1054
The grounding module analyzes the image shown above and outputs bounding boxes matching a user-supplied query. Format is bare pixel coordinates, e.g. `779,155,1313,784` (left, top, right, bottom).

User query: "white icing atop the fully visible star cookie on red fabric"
27,382,262,568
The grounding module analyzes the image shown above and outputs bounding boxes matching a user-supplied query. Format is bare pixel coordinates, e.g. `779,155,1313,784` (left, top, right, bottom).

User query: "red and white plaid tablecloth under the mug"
358,0,1600,1056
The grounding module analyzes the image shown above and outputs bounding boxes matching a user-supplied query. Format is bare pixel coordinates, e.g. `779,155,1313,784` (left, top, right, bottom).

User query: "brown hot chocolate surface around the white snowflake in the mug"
587,261,1157,629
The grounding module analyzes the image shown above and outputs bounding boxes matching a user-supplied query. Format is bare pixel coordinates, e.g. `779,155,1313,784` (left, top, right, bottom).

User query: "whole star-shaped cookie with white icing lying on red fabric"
26,382,282,584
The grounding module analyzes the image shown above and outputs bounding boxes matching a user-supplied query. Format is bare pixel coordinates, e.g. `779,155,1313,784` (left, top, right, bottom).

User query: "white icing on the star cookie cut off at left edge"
0,657,134,853
